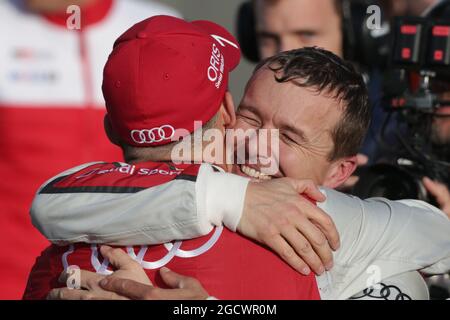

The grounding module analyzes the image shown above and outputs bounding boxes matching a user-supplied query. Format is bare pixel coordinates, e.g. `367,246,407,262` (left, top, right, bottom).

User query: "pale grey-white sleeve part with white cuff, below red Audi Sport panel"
30,163,249,245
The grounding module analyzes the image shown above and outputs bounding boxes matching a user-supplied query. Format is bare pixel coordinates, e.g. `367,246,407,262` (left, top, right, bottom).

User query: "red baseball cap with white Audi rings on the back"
102,16,240,147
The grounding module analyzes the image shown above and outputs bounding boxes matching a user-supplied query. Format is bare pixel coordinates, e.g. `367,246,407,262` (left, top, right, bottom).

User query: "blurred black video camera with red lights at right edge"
352,17,450,203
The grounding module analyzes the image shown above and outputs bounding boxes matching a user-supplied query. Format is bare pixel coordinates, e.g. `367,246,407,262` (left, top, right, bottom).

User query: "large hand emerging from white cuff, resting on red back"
237,178,340,275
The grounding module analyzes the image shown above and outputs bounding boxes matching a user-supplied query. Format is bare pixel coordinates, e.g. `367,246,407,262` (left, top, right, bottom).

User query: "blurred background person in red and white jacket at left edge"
0,0,178,299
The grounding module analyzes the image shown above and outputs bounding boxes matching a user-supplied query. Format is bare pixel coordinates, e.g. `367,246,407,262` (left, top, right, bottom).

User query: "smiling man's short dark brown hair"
255,47,371,161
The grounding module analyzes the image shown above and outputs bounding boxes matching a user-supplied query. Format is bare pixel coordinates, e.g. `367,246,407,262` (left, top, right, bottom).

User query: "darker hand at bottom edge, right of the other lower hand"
100,267,209,300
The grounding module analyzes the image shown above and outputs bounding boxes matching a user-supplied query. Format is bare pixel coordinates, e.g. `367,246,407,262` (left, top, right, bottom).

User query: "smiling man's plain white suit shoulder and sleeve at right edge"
318,189,450,299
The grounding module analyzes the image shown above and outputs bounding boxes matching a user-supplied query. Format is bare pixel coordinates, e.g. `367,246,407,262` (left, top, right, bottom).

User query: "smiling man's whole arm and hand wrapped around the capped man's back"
31,163,339,274
